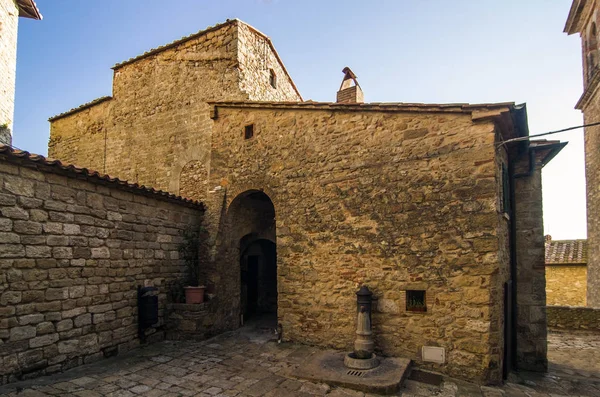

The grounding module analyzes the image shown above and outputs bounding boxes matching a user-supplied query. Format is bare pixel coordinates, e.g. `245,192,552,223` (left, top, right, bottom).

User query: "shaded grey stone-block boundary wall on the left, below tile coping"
0,152,202,383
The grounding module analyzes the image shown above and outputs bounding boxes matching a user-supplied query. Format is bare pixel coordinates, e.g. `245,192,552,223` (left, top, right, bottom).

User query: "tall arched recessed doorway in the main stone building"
227,190,277,323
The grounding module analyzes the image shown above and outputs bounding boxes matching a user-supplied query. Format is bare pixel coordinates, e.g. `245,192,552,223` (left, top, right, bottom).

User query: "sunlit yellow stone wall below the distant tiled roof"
546,265,587,306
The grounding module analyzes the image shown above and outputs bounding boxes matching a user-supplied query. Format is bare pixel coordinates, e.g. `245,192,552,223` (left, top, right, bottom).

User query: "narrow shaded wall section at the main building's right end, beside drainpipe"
514,163,548,372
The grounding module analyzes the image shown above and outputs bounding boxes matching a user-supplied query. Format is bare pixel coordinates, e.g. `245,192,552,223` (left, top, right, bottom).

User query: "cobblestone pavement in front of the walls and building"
0,328,600,397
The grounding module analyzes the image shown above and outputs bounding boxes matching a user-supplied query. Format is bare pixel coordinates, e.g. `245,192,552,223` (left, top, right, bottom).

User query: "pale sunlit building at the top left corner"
0,0,42,145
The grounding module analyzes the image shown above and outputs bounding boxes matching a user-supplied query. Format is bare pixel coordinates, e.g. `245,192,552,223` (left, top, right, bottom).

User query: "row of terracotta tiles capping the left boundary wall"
0,144,205,210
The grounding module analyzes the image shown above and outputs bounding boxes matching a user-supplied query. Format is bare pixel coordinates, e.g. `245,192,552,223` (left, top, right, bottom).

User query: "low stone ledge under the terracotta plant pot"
166,298,237,340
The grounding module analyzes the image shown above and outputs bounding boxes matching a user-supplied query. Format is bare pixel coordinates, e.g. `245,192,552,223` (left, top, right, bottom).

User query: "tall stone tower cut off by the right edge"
564,0,600,307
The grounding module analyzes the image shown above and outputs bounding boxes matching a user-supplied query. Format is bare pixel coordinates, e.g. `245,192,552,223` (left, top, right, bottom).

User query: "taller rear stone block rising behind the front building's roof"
48,20,301,198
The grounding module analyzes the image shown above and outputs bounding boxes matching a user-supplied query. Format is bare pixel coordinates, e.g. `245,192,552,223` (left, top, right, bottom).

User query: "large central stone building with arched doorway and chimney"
44,20,564,383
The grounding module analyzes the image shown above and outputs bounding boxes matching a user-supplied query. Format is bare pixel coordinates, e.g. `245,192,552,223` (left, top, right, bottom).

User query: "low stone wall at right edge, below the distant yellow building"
547,306,600,333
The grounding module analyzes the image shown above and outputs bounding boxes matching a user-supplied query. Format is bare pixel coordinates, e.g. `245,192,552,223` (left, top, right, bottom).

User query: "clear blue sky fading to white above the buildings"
13,0,585,239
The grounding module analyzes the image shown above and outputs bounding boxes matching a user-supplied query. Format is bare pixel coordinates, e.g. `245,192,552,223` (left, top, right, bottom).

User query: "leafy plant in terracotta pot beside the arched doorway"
179,226,206,303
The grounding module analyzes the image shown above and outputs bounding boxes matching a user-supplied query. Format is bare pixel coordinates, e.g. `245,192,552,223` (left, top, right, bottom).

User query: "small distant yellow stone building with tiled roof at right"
546,236,587,306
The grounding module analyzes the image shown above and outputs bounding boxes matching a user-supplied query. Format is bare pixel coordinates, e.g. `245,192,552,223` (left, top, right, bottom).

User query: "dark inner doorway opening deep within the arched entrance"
240,236,277,321
